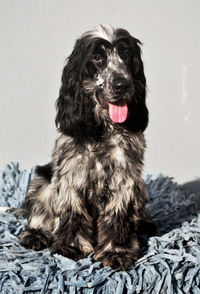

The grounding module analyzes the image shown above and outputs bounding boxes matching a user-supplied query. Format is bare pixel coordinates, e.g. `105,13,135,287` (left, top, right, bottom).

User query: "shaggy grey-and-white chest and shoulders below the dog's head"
55,135,144,203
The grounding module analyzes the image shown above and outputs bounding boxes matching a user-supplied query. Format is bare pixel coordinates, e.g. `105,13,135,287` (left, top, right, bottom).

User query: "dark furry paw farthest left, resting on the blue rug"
19,228,53,251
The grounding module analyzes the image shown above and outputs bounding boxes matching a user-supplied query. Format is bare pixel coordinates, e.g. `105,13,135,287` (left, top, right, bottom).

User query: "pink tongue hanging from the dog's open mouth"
108,102,128,123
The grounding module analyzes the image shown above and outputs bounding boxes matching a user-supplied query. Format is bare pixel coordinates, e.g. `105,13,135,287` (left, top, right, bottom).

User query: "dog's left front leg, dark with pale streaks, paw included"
51,187,93,260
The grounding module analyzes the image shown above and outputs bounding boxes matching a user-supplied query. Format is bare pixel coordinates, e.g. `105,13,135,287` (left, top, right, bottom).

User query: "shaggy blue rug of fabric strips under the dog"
0,163,200,294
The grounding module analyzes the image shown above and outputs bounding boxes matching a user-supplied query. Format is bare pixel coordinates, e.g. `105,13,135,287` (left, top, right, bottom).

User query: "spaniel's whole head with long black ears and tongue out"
56,25,148,137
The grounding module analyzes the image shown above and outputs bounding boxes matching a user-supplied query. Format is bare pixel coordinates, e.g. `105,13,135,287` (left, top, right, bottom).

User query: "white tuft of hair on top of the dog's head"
82,24,114,43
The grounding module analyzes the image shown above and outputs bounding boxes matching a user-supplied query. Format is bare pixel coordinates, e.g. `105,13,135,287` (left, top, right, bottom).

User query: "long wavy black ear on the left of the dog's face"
55,39,99,137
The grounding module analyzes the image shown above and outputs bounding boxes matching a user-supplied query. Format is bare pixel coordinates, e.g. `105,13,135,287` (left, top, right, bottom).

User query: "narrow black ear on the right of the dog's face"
125,36,149,132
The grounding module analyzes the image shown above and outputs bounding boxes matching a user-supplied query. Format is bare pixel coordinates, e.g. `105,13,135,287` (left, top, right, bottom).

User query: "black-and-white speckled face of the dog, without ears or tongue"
83,36,134,103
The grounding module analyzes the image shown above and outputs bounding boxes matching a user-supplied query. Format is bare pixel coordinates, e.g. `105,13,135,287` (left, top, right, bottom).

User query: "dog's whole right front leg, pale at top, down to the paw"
94,178,145,270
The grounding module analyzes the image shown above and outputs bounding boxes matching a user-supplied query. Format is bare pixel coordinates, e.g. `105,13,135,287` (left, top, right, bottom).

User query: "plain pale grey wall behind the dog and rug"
0,0,200,183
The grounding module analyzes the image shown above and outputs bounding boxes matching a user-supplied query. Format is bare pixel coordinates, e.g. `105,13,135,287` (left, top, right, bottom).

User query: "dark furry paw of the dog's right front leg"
93,251,137,271
